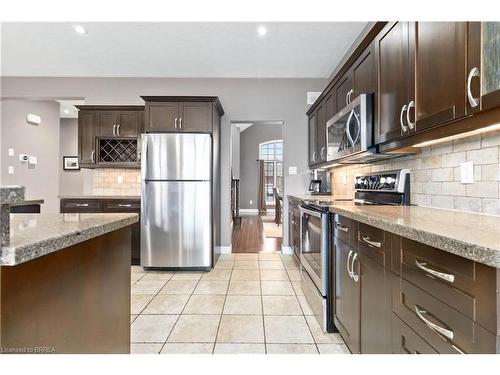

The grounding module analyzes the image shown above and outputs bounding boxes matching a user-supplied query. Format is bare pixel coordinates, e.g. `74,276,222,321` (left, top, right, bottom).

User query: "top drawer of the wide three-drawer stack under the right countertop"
400,238,497,332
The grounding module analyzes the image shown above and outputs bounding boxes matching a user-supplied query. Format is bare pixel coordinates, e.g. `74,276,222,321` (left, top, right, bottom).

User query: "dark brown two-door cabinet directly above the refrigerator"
142,96,224,133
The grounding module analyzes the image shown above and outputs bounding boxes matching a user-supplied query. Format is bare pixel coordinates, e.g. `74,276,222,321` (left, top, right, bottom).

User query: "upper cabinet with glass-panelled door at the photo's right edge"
466,22,500,113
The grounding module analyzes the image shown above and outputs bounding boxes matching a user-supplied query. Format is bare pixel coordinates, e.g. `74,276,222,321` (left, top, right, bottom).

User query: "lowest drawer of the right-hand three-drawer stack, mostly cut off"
392,314,437,354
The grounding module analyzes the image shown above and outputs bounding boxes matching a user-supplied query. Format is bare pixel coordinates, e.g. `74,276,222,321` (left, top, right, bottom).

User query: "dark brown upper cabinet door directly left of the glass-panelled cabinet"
407,22,467,131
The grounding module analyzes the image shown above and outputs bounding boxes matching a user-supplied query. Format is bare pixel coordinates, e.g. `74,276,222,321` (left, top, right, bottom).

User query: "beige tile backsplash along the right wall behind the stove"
331,131,500,215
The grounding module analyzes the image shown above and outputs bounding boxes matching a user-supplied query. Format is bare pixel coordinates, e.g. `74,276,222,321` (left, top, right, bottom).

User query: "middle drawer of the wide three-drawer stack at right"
392,277,496,354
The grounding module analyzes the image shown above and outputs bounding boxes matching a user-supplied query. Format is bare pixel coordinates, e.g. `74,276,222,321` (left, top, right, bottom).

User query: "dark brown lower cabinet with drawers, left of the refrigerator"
60,197,141,265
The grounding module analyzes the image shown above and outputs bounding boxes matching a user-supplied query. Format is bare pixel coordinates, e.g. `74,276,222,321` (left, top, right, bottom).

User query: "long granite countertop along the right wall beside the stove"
292,195,500,268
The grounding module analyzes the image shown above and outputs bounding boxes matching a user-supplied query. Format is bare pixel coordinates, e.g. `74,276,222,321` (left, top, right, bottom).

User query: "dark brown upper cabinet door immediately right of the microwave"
375,22,415,143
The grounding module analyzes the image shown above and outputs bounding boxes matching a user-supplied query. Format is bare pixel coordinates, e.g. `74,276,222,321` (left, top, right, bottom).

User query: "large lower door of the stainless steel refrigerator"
141,181,212,268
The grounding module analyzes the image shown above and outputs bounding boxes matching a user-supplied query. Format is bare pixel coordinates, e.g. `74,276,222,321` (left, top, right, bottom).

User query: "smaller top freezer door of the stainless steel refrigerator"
141,134,212,180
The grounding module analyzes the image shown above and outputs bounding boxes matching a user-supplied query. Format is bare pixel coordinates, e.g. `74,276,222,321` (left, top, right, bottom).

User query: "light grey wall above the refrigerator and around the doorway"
2,77,328,245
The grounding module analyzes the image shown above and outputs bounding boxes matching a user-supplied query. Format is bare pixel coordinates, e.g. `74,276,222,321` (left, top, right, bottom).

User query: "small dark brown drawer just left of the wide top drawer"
358,223,393,268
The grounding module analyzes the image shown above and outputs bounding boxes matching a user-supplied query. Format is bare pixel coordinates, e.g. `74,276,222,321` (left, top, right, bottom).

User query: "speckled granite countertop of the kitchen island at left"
0,213,139,266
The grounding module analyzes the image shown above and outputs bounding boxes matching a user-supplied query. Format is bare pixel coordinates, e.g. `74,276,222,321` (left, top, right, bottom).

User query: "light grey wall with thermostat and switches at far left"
1,100,62,212
